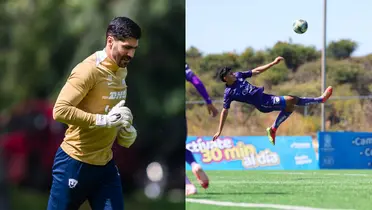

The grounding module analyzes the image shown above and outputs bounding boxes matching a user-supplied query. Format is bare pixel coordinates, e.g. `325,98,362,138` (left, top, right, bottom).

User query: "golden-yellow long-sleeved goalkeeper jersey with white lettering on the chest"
53,50,127,165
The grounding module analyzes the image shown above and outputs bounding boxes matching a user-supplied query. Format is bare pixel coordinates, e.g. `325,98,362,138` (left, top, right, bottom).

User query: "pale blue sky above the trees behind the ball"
186,0,372,56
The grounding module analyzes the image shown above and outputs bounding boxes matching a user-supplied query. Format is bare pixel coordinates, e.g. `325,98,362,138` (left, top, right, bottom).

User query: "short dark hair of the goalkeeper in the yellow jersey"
106,17,142,41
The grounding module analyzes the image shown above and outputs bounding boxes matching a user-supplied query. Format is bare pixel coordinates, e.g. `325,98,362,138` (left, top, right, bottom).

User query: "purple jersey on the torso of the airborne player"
223,70,264,109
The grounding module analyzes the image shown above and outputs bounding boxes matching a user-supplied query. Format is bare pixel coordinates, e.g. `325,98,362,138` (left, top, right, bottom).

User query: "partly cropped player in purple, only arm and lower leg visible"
185,64,218,195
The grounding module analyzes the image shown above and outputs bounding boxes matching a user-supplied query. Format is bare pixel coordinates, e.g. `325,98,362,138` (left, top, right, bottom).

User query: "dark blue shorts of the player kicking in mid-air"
255,93,286,113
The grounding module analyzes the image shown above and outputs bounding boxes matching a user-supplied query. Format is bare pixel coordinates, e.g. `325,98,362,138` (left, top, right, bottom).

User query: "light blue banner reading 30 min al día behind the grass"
186,136,318,170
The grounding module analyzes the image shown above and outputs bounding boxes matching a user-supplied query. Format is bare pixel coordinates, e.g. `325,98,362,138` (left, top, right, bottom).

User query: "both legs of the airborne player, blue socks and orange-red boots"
266,86,333,145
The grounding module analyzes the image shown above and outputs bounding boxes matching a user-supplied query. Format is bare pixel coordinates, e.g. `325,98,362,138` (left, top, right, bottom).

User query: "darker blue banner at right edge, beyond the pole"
318,132,372,169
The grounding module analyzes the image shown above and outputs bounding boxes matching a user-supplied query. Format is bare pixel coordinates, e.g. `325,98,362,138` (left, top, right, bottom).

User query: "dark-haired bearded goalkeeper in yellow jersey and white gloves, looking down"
48,17,141,210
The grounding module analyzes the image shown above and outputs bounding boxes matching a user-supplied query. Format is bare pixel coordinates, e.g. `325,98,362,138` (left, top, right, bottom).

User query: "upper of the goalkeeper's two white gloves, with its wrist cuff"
96,100,133,128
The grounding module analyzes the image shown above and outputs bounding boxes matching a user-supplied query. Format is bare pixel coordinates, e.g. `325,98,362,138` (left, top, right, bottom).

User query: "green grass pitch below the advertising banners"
186,170,372,210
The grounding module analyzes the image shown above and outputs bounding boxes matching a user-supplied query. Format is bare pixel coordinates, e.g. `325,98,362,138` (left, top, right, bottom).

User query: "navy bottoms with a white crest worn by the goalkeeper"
48,148,124,210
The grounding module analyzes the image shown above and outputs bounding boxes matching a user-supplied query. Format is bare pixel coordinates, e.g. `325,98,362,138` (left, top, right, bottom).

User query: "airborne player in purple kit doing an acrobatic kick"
213,57,332,145
